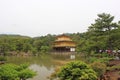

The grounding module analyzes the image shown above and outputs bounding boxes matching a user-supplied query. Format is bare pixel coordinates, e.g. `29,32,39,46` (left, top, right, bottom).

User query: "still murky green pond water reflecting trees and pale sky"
7,55,74,80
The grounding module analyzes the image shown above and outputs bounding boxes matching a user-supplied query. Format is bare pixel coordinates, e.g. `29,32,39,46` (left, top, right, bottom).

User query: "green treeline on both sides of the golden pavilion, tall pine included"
0,13,120,54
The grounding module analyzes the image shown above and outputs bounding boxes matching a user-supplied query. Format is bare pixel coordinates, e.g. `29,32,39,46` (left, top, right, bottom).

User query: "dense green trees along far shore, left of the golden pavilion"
0,34,54,55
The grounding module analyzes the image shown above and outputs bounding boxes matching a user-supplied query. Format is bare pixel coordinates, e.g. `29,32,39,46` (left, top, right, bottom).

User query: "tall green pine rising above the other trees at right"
88,13,118,50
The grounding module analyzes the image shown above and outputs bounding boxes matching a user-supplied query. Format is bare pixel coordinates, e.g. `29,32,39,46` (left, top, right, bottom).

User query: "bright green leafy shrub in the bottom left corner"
0,64,36,80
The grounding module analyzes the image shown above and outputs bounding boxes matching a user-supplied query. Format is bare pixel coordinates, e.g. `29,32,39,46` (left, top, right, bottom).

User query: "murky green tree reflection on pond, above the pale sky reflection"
7,54,73,70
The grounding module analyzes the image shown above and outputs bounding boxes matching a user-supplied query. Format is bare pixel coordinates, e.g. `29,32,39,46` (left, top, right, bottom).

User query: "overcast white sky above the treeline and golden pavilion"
0,0,120,37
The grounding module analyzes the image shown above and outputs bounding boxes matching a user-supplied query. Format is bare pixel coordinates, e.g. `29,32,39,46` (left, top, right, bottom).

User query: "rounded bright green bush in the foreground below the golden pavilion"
58,61,97,80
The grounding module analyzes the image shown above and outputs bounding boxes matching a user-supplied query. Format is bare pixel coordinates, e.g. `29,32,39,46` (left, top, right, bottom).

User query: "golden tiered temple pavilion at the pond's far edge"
53,34,76,52
